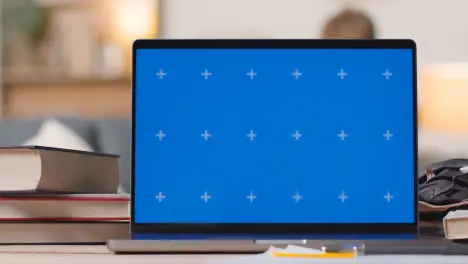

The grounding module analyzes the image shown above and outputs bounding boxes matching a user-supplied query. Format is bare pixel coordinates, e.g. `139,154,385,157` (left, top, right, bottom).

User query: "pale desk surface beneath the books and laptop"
0,246,468,264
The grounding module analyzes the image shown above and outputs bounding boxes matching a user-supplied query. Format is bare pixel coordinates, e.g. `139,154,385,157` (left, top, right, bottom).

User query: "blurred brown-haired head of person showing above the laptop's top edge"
321,9,376,39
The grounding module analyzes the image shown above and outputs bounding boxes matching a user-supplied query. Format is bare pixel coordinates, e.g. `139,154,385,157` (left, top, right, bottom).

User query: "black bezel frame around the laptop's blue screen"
131,39,418,238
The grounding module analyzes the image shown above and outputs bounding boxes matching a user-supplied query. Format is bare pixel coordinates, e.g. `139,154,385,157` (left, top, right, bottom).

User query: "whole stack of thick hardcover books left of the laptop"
0,146,130,244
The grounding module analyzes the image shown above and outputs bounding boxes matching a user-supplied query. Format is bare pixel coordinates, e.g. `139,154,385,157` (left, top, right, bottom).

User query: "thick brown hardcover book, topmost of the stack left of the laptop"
0,146,119,193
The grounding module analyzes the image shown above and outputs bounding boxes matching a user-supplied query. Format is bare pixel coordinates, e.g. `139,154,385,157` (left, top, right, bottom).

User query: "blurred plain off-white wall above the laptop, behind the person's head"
161,0,468,62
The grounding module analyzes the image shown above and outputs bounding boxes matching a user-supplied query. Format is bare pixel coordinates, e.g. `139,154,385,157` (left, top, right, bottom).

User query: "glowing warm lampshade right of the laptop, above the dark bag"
419,62,468,132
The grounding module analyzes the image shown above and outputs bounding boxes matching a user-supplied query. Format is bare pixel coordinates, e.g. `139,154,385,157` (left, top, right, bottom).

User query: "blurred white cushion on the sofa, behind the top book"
23,118,93,151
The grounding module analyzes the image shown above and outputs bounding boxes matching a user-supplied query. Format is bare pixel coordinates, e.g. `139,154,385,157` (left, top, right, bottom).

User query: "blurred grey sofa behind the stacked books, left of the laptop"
0,117,131,193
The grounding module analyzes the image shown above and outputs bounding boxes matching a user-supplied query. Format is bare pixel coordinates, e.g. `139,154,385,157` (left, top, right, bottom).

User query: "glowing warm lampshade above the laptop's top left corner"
112,0,158,41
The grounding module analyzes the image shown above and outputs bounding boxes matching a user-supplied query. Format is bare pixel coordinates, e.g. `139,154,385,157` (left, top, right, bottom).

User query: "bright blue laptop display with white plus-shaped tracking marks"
134,49,415,224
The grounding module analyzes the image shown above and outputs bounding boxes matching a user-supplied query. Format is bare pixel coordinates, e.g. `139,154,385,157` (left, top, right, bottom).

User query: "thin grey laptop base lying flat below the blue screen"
107,238,468,255
